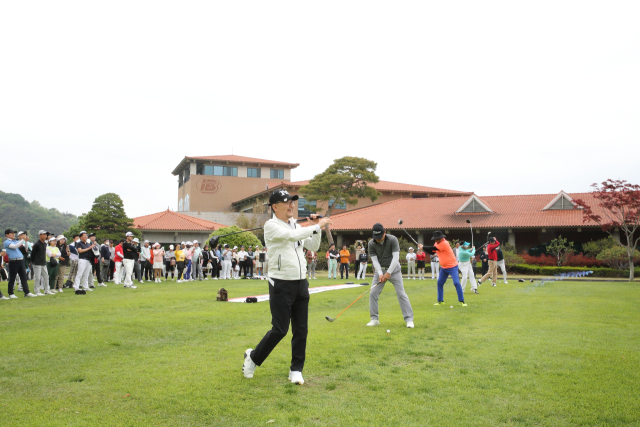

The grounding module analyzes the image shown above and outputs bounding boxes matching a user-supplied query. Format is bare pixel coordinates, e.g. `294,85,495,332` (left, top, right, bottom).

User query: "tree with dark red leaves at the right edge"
573,179,640,281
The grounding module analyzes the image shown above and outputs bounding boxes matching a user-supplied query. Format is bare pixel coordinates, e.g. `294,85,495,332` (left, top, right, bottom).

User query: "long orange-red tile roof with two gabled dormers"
331,193,597,231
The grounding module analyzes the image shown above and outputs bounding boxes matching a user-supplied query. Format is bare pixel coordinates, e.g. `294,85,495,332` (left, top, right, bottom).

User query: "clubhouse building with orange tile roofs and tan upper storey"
134,155,618,252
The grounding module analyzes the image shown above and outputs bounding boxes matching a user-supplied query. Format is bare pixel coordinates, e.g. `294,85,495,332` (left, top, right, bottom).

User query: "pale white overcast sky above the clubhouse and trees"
0,0,640,216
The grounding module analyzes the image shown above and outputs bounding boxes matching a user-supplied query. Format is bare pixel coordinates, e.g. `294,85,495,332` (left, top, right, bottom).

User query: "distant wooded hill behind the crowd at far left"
0,191,78,237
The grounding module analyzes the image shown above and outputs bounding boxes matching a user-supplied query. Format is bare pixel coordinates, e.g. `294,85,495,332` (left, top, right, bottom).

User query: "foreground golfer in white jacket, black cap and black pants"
242,190,331,384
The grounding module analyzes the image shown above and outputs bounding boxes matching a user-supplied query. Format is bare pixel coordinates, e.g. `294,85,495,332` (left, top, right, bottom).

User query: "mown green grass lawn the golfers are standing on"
0,279,640,427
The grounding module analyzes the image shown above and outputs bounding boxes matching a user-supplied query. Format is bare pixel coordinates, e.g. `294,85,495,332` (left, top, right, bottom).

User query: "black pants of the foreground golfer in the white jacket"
251,279,309,372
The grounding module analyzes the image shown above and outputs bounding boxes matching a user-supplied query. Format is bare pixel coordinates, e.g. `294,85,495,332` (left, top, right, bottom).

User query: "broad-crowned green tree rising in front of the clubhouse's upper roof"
300,157,380,216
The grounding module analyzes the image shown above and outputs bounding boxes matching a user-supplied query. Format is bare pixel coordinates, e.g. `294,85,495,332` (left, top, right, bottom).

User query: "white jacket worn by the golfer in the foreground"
264,217,322,284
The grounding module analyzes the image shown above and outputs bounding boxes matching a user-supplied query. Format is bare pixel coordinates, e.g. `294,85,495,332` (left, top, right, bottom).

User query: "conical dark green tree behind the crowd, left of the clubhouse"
65,193,142,240
